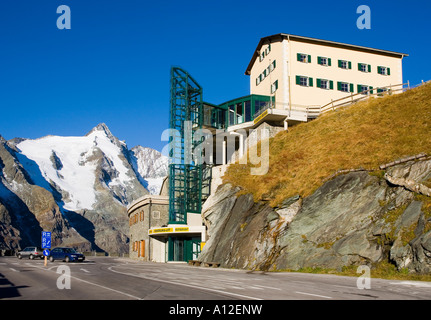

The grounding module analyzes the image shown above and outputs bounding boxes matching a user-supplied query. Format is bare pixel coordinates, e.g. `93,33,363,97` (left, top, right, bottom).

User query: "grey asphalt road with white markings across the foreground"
0,257,431,300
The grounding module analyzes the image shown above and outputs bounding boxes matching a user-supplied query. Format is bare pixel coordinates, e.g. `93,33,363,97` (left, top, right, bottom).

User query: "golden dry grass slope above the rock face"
224,84,431,206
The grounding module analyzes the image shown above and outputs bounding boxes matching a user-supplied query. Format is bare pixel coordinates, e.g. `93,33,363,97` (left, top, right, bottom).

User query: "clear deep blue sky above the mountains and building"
0,0,431,150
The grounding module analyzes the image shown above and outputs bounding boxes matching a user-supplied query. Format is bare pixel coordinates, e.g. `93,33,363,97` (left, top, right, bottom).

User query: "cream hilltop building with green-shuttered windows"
245,33,407,115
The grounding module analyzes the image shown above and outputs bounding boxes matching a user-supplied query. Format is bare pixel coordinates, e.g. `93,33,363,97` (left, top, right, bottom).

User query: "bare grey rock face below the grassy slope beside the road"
199,158,431,273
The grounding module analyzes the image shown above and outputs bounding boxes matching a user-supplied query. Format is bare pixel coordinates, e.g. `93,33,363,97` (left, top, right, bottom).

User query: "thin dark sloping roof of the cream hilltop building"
245,33,408,75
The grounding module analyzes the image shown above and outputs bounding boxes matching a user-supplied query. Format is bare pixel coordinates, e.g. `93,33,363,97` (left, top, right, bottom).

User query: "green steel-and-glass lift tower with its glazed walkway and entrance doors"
168,67,271,261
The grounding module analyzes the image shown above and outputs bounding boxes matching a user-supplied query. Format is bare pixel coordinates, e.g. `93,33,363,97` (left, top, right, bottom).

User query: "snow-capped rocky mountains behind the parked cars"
0,124,167,252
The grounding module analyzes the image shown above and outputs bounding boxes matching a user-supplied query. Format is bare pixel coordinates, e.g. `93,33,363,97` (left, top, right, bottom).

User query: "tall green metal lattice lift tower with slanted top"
169,67,211,224
